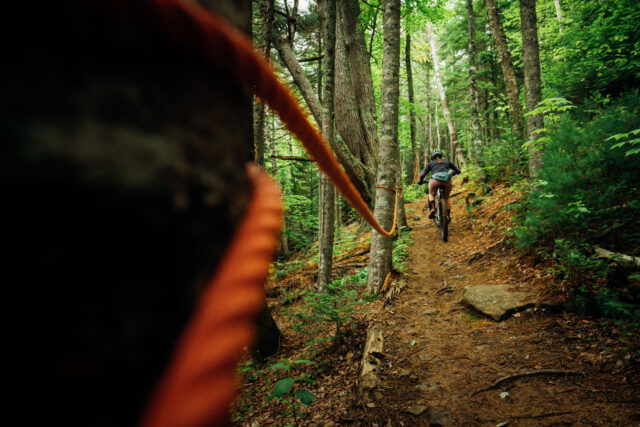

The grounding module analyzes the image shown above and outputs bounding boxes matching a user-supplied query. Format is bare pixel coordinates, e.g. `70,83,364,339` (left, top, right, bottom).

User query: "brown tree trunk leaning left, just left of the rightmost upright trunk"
485,0,525,140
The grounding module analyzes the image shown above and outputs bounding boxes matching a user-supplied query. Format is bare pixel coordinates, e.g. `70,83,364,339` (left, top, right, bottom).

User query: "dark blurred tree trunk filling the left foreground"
0,0,284,426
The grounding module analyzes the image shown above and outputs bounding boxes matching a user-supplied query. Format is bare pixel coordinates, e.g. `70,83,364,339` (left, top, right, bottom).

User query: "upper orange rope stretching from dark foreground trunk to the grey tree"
114,0,395,237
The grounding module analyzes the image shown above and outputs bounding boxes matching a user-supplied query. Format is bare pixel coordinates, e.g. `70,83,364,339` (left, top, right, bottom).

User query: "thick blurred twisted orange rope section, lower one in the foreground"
142,165,282,427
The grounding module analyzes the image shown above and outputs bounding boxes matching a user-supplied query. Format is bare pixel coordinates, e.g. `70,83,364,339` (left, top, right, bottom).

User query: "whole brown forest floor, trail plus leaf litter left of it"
234,181,640,426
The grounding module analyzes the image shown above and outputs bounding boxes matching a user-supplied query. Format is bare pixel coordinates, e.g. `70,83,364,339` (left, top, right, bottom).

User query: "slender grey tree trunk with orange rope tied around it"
367,0,400,293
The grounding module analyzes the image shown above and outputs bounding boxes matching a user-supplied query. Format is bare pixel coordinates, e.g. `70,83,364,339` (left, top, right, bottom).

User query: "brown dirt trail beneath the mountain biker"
370,190,640,426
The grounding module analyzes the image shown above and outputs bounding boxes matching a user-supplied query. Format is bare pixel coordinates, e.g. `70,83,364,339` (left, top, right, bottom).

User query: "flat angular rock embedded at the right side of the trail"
462,285,534,321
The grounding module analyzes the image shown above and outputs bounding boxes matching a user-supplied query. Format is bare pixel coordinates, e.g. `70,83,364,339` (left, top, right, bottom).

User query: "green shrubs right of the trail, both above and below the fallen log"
514,95,640,322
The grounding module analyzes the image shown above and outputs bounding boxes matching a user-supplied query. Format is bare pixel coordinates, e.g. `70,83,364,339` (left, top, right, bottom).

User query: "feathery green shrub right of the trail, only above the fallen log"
516,97,640,250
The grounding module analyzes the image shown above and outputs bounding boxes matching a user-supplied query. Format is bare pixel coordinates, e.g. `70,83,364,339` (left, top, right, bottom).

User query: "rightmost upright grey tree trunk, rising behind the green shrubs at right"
520,0,544,177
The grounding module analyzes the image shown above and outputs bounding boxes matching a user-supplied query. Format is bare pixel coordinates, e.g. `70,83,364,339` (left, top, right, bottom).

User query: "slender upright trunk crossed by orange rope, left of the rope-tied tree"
318,0,336,292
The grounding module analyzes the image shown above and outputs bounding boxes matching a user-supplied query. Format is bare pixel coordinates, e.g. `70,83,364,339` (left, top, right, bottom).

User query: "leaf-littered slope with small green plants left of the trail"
233,224,411,425
